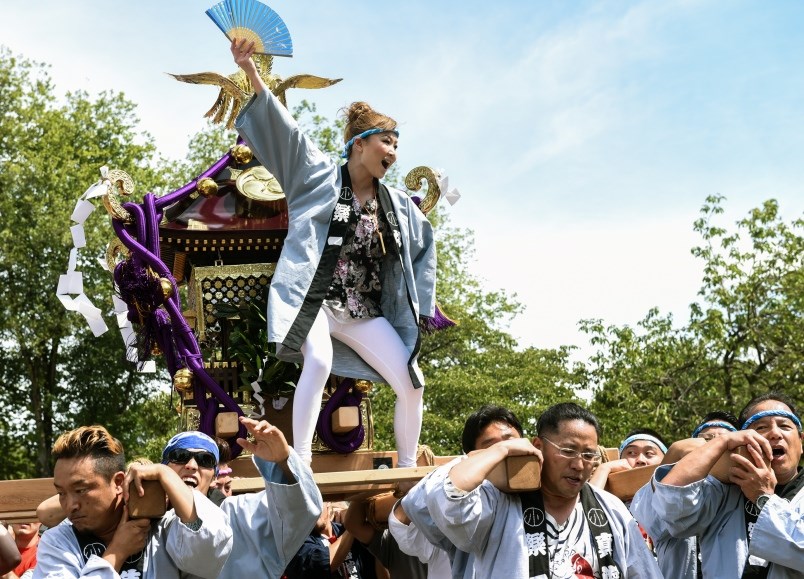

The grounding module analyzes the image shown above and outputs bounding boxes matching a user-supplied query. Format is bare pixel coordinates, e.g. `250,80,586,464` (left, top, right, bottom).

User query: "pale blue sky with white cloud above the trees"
0,0,804,353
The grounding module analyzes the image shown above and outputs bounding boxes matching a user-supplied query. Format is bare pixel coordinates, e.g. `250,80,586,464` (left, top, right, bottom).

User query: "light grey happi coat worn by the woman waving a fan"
236,91,436,387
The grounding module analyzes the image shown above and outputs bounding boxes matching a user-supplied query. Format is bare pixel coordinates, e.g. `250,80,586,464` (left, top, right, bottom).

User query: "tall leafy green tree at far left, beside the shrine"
0,48,171,476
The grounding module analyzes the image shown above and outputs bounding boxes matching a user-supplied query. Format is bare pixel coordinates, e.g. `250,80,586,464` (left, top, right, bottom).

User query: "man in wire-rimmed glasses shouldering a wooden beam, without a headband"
420,403,661,579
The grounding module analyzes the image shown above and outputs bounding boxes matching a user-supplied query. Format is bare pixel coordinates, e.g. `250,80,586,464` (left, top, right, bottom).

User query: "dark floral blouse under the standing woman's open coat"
324,196,390,321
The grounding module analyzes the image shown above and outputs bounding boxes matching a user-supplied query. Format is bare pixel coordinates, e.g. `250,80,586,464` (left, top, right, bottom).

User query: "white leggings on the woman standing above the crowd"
293,308,424,467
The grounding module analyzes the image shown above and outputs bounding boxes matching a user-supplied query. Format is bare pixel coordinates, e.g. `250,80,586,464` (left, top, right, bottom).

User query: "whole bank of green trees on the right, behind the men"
581,197,804,444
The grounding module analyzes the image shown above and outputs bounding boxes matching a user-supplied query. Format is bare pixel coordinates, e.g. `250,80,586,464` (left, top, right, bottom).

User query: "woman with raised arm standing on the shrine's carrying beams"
231,38,436,467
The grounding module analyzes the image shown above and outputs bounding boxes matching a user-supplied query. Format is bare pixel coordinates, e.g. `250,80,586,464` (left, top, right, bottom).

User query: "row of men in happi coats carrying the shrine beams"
0,394,804,579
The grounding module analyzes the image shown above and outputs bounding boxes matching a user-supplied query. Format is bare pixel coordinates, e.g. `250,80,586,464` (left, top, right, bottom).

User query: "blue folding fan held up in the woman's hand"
207,0,293,56
